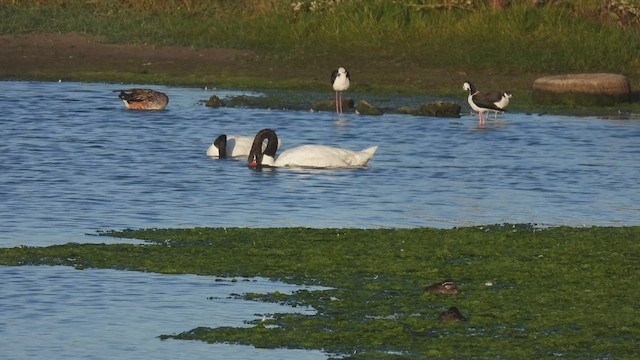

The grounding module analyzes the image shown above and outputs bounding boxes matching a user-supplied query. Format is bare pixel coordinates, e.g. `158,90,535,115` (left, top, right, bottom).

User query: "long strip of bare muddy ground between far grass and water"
0,34,537,95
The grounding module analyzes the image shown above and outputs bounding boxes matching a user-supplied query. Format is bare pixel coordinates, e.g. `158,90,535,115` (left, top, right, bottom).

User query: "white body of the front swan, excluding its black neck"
262,145,378,168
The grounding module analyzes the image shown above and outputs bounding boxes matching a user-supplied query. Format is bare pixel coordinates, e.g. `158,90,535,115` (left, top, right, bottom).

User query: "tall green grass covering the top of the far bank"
0,0,640,81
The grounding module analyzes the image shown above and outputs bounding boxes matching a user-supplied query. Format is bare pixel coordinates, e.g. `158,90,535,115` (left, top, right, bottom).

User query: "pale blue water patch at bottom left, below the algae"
0,266,326,360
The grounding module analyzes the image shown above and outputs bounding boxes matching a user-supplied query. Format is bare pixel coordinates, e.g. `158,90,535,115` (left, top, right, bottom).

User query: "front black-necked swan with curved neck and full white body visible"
248,129,378,168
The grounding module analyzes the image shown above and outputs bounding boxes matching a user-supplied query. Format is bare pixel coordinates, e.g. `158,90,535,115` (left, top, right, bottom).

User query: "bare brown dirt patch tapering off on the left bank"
0,34,253,80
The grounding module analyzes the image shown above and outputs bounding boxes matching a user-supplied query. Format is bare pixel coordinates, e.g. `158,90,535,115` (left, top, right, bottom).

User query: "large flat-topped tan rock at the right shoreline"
533,73,631,106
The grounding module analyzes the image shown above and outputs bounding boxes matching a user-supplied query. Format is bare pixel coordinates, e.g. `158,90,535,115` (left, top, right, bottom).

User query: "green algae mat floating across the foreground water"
0,224,640,359
